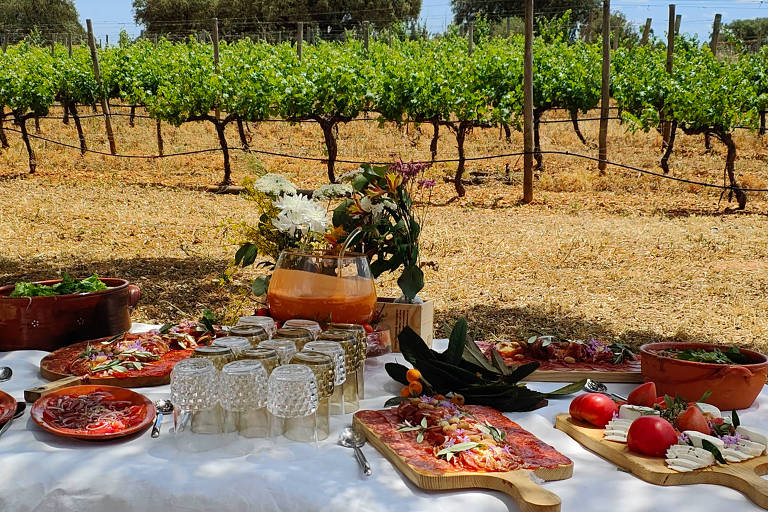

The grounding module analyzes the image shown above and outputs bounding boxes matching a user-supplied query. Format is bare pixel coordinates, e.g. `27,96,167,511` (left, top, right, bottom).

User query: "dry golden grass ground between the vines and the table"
0,105,768,348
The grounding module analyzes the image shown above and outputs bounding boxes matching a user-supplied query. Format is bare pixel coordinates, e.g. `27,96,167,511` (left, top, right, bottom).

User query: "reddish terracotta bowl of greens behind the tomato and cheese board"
640,343,768,410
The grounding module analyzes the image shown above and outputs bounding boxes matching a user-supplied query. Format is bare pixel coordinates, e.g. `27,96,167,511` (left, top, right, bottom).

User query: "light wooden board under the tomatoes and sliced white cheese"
555,414,768,509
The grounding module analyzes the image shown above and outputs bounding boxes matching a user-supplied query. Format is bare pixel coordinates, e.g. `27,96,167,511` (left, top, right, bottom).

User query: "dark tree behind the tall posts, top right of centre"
451,0,602,27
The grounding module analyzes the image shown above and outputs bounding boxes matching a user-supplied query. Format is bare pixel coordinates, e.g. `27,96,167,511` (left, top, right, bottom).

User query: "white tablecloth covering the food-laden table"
0,328,768,512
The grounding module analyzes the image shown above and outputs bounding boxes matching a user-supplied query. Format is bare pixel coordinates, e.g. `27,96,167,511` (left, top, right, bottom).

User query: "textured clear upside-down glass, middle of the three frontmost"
220,359,270,437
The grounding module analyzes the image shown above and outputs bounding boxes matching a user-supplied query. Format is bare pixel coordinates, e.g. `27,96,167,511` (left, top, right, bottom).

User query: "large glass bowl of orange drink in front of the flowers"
267,251,376,323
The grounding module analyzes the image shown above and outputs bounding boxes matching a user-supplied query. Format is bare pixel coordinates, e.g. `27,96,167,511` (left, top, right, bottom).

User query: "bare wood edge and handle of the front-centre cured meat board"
353,415,573,512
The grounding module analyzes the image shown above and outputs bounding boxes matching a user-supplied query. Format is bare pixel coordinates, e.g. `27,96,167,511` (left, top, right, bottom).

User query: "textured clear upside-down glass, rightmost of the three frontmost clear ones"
267,364,317,442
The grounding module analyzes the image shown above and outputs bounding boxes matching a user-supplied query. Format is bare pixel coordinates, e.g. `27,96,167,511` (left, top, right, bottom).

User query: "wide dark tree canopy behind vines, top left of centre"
133,0,421,37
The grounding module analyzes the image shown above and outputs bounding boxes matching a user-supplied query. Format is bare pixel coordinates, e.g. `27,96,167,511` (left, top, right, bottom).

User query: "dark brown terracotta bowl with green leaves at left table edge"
0,278,141,351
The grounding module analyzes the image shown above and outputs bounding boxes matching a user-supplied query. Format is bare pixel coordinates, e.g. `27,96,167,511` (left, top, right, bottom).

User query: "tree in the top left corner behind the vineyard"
0,0,85,40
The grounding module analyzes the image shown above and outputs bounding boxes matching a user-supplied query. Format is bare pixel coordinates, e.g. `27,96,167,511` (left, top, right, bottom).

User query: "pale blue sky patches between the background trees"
74,0,768,41
